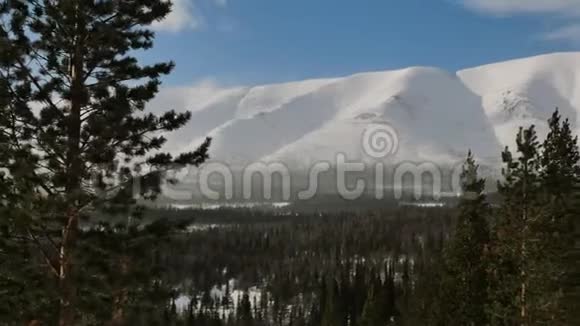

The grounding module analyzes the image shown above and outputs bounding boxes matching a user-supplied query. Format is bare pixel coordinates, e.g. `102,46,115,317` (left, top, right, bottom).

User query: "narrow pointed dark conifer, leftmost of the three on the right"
439,152,490,326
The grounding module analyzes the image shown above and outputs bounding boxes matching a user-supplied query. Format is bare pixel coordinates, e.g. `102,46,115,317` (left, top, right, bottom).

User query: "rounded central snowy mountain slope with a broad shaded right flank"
266,68,501,168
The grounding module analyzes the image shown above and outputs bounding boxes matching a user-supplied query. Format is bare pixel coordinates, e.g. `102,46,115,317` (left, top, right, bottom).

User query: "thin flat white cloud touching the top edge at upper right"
462,0,580,16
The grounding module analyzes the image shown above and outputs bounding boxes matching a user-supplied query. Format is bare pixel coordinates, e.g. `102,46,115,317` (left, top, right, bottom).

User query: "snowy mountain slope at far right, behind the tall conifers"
458,53,580,147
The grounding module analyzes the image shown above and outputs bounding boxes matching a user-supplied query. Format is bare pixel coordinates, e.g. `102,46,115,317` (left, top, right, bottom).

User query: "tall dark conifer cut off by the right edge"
540,109,580,324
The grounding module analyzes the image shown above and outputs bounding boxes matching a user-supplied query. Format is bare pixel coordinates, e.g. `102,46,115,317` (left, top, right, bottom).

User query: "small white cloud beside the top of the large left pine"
153,0,203,32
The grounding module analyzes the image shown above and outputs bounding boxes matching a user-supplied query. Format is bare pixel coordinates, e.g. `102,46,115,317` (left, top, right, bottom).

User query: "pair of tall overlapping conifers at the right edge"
489,111,580,325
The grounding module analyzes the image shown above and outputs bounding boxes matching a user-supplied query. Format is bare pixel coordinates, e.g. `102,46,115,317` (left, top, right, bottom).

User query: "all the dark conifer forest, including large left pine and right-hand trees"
0,0,580,326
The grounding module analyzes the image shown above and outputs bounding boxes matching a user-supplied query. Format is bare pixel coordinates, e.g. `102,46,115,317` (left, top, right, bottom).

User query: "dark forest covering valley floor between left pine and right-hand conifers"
134,209,452,326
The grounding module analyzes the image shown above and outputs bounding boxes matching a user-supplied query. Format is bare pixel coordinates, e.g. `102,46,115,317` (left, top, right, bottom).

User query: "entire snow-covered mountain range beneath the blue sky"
152,53,580,168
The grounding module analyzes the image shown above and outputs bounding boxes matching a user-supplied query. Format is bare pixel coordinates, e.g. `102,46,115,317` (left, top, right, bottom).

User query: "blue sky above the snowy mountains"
143,0,580,86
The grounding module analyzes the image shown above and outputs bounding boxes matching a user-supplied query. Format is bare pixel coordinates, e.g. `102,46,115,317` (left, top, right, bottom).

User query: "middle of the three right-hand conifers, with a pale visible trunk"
490,126,539,325
